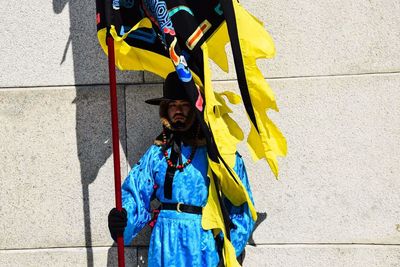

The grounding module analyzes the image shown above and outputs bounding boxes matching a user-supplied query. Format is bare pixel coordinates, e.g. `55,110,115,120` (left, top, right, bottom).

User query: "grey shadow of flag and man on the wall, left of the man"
53,0,159,267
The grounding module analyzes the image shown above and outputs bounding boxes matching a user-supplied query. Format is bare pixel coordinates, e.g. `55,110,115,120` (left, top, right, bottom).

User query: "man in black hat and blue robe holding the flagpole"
108,72,254,267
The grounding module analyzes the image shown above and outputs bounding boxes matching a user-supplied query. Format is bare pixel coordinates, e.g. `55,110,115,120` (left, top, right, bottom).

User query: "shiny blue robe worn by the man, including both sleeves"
122,145,254,267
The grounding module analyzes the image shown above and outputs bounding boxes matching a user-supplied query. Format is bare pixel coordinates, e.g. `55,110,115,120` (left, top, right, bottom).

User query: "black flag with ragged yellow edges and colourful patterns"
96,0,287,266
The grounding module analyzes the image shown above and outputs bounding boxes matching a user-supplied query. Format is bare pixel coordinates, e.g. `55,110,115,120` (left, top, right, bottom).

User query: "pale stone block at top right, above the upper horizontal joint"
145,0,400,82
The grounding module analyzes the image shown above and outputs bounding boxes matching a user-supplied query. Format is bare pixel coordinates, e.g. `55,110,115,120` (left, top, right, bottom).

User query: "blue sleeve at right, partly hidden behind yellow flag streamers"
225,153,255,256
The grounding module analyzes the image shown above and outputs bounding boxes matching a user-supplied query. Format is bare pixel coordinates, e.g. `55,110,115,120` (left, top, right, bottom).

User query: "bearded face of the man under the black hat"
168,100,193,128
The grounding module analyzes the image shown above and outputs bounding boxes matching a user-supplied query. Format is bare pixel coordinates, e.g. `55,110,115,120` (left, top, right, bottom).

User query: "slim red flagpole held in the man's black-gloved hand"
107,35,125,267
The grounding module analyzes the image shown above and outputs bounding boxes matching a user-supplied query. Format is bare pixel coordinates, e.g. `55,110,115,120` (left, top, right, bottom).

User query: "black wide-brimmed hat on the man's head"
144,71,189,105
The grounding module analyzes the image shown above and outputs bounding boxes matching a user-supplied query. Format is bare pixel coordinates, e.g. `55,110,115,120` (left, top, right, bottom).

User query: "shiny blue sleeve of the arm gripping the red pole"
122,145,158,245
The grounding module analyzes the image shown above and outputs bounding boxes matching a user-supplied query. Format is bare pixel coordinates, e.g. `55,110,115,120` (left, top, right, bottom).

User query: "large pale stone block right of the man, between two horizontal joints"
215,74,400,244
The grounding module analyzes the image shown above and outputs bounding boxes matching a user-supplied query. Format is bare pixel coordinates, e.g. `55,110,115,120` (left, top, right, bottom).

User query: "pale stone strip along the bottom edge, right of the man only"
243,245,400,267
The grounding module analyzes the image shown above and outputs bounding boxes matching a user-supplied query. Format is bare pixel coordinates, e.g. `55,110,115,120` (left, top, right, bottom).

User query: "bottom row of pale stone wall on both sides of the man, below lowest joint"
0,245,400,267
